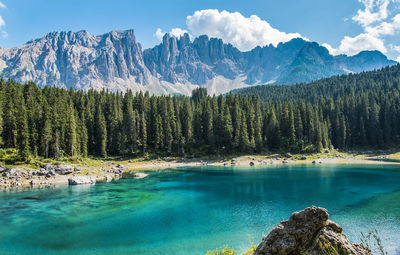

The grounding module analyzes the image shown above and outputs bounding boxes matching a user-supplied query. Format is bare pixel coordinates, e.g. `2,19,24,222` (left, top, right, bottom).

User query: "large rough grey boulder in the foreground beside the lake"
254,206,372,255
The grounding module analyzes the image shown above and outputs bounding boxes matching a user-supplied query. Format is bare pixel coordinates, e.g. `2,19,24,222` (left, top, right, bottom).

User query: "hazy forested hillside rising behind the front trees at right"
232,64,400,103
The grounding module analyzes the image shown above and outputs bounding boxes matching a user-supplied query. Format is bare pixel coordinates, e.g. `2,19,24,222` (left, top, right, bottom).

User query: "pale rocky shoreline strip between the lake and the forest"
0,153,400,192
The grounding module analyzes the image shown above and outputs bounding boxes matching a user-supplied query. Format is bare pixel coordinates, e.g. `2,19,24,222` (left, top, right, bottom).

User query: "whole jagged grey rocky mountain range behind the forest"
0,30,397,95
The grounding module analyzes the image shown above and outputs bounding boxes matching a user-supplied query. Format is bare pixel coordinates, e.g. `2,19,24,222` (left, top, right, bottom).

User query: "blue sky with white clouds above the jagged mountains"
0,0,400,61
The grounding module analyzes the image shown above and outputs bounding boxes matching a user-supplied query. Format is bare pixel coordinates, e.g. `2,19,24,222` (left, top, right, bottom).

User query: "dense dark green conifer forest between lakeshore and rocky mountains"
0,63,400,159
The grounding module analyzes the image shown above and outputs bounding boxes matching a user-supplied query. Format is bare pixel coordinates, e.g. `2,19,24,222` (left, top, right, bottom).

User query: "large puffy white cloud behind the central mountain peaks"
186,9,306,51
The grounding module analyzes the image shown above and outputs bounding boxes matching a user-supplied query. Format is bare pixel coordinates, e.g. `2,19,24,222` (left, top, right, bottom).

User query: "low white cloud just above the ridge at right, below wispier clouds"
323,33,387,56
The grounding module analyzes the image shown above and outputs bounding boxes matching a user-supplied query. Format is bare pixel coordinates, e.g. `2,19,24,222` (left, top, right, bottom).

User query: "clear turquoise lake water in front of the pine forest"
0,166,400,255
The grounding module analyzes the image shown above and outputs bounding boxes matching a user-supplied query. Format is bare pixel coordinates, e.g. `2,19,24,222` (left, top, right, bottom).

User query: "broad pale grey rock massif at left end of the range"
0,30,150,90
